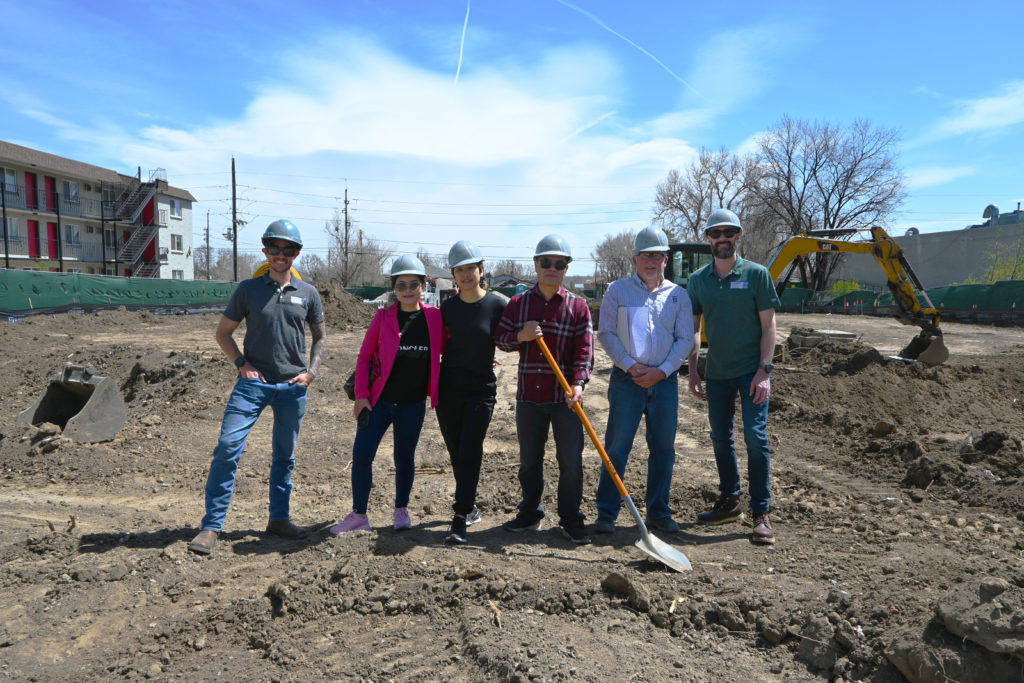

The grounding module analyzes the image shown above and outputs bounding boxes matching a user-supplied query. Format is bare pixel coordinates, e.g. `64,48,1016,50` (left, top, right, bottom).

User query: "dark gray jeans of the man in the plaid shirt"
515,400,583,528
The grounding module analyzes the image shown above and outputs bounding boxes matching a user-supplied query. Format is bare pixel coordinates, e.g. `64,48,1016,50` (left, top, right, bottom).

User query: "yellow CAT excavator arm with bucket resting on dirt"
768,226,949,365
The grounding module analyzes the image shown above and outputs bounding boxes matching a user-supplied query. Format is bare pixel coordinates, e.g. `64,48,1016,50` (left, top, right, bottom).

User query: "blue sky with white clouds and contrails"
0,0,1024,272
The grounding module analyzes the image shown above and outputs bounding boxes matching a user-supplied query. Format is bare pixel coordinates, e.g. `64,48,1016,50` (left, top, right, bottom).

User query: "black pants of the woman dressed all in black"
435,387,495,515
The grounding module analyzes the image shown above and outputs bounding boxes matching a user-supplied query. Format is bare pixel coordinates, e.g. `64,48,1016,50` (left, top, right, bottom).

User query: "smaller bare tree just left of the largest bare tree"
654,147,759,242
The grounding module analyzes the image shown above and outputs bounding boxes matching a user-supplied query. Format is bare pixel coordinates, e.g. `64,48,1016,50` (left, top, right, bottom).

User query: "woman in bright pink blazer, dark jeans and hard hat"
331,256,444,536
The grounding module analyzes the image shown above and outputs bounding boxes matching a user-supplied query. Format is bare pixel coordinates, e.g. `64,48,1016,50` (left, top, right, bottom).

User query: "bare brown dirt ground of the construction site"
0,305,1024,682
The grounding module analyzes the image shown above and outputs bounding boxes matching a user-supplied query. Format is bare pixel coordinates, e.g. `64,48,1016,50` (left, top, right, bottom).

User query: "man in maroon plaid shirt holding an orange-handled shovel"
495,234,594,544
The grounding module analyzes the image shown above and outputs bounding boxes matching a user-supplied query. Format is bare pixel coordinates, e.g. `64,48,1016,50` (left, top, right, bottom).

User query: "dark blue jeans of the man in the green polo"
706,373,771,514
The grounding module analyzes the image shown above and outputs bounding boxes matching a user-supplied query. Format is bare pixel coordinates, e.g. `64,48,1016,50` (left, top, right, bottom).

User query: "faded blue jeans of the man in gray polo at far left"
202,378,306,531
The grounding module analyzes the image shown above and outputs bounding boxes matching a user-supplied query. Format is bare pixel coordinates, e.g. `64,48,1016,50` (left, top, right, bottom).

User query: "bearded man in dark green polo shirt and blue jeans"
686,209,780,544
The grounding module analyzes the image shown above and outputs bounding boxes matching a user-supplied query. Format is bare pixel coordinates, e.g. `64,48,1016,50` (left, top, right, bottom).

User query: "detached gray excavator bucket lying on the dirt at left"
17,362,127,443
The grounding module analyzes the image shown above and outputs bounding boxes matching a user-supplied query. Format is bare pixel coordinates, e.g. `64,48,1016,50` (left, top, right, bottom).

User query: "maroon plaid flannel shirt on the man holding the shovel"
495,286,594,403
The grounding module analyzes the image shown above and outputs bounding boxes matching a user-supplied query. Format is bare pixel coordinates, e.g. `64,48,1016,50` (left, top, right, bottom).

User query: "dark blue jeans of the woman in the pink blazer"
352,400,427,514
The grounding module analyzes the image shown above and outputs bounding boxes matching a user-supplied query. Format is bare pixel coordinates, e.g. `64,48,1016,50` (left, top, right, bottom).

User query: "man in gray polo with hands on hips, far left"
188,220,327,555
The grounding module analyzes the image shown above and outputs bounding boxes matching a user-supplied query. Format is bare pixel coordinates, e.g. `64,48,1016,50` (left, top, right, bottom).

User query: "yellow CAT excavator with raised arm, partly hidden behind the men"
665,227,949,366
